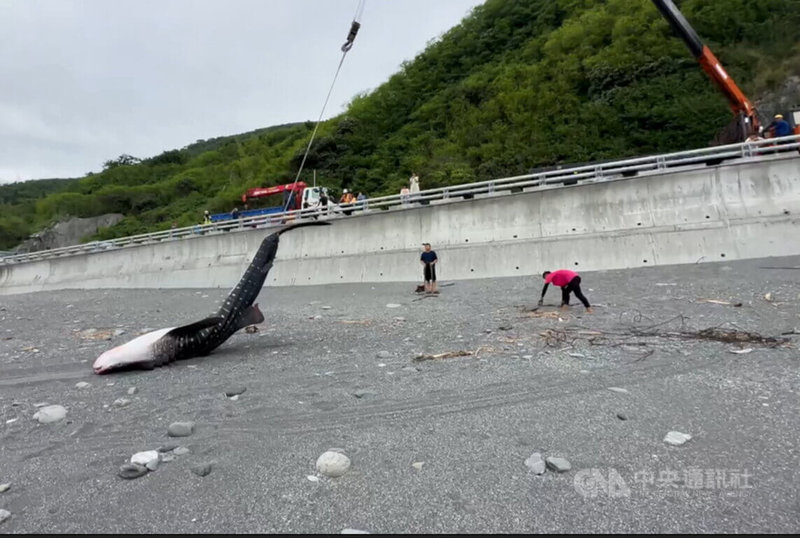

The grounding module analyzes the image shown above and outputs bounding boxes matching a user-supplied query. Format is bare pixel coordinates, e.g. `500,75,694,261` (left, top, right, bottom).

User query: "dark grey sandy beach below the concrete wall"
0,257,800,533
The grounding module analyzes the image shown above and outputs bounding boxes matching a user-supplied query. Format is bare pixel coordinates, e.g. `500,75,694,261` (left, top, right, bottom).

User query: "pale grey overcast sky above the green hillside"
0,0,483,183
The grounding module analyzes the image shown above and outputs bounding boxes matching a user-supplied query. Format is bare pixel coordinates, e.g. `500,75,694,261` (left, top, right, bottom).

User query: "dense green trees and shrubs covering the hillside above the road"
0,0,800,249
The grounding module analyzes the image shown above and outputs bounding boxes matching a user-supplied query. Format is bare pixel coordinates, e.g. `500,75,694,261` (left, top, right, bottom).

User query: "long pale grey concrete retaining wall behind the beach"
0,153,800,294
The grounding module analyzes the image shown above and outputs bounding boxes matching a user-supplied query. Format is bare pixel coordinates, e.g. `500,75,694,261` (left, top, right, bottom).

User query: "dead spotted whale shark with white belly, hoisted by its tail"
92,221,330,374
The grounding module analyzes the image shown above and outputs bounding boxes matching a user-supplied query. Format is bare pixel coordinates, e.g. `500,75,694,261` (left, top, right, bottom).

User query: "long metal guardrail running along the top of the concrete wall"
0,135,800,265
